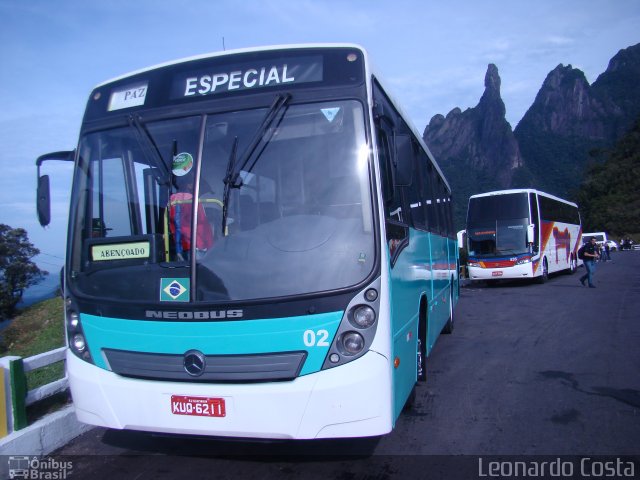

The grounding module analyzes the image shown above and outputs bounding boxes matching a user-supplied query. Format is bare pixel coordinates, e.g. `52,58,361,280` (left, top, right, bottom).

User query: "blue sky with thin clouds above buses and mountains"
0,0,640,271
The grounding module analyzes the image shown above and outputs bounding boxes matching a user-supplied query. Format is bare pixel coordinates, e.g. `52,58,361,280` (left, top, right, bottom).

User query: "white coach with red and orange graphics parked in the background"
466,189,582,283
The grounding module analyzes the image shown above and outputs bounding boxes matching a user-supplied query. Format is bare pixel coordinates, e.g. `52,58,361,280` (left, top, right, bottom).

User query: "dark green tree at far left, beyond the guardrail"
0,223,47,320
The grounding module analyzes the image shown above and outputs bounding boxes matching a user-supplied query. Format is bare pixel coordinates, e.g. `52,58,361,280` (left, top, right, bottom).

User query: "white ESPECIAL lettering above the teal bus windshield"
184,63,295,97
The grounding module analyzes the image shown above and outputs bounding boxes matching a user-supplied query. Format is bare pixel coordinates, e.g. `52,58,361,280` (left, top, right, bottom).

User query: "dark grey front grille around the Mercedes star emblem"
103,349,307,382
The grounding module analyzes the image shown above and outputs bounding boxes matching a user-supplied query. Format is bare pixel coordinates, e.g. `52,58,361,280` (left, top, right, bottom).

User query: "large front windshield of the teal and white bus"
70,100,375,302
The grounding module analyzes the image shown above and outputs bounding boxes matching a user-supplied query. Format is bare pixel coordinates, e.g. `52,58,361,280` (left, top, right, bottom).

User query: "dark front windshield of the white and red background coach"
467,193,530,257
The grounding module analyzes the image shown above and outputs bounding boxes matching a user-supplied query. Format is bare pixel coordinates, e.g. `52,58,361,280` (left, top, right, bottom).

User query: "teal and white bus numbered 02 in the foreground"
37,45,459,439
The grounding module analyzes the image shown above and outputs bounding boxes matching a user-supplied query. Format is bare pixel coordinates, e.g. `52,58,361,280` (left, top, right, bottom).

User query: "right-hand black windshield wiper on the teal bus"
222,93,291,236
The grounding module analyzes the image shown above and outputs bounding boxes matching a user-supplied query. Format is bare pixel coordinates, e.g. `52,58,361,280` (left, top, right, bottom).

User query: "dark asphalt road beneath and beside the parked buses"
53,252,640,480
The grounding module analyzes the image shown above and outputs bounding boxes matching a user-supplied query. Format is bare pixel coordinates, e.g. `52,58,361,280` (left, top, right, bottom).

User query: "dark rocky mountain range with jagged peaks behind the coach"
423,44,640,229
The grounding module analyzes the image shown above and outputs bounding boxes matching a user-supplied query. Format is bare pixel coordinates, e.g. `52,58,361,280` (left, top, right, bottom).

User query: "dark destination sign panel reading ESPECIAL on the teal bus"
171,56,322,98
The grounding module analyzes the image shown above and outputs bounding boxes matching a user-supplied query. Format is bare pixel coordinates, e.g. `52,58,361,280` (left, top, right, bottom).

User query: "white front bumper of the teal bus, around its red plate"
67,351,393,439
